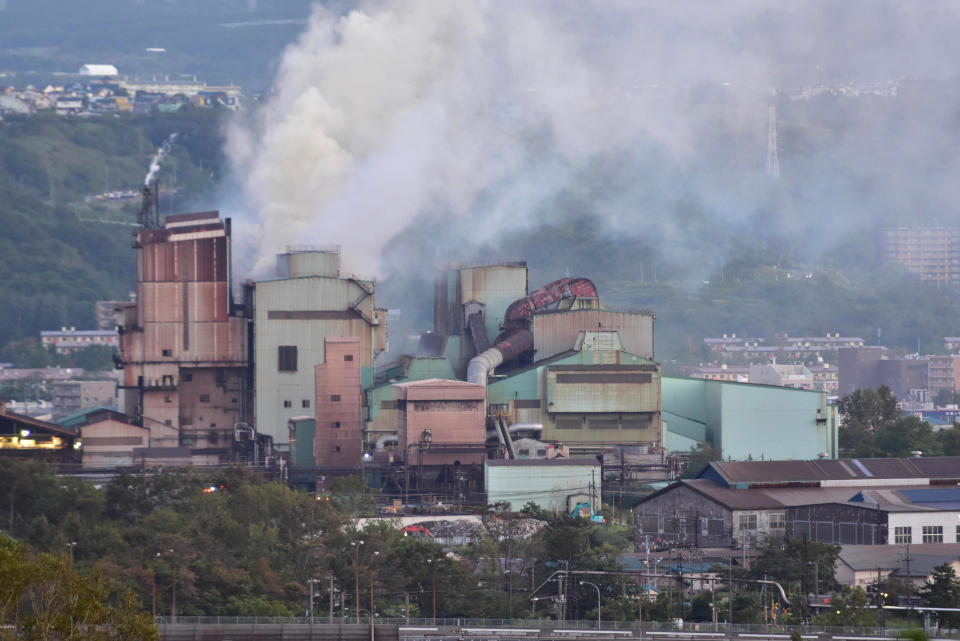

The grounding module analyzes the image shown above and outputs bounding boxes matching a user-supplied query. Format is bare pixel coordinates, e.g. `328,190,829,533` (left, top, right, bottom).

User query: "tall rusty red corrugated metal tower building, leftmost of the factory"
119,211,247,461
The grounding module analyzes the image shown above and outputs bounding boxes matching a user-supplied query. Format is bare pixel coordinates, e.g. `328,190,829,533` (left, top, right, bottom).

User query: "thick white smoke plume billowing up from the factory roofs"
228,0,957,277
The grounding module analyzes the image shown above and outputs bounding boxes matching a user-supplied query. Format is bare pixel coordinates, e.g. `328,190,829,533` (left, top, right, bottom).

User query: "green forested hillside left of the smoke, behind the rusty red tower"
0,107,223,345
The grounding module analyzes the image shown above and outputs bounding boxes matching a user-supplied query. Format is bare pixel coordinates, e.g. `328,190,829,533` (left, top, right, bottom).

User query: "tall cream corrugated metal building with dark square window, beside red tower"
253,247,387,449
